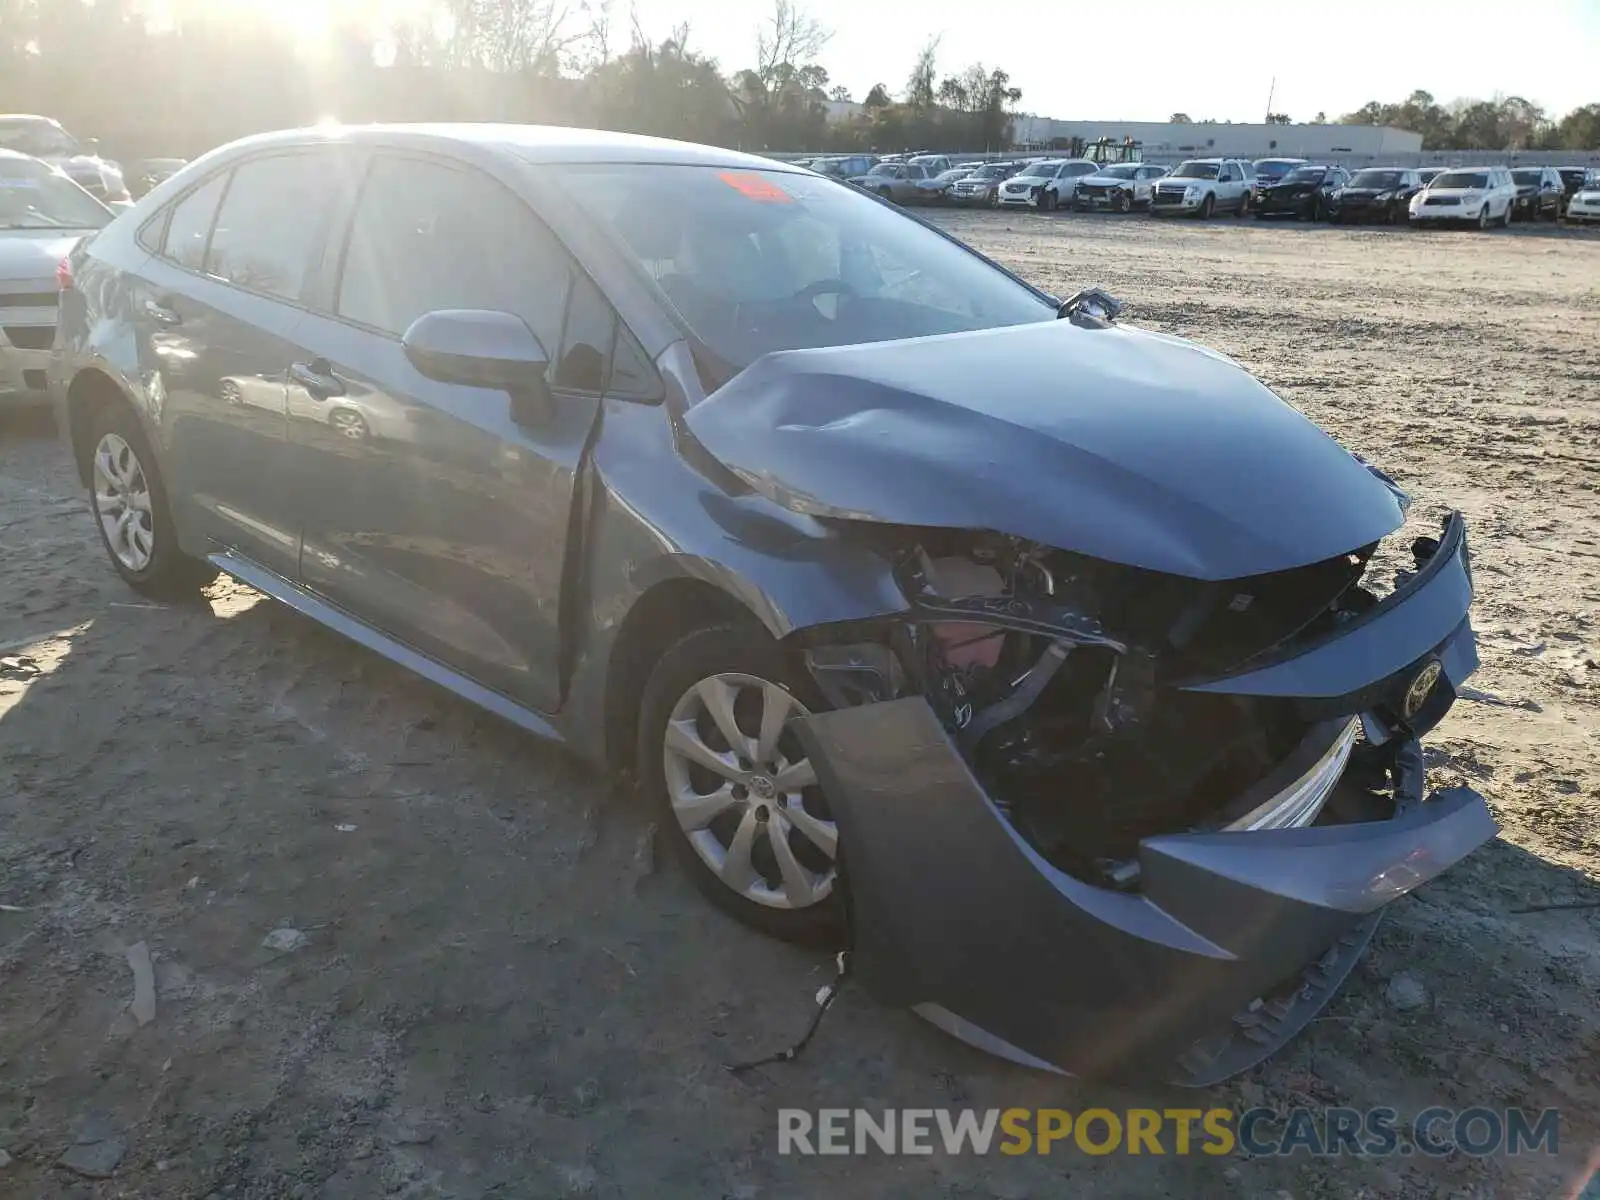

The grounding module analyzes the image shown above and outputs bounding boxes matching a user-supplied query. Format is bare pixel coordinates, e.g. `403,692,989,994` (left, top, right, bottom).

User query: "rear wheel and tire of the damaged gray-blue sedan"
85,405,218,600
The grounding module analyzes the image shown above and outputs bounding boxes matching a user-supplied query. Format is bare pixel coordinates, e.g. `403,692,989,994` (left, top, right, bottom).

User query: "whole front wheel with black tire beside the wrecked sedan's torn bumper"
635,622,846,946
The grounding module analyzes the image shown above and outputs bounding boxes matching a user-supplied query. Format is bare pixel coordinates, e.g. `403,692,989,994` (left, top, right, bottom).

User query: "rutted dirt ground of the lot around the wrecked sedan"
0,213,1600,1200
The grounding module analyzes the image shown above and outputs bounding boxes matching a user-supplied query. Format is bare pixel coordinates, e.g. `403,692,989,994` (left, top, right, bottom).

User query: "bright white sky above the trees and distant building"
613,0,1600,122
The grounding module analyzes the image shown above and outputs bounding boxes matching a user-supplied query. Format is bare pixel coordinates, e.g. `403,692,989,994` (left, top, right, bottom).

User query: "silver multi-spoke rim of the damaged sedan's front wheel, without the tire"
662,672,838,909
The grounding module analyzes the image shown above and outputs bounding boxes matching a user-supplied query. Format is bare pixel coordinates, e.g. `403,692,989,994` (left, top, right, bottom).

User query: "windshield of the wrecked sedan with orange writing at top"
560,163,1056,371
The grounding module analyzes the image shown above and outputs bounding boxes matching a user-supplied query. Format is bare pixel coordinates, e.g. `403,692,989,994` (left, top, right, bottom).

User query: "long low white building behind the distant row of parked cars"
1011,115,1422,160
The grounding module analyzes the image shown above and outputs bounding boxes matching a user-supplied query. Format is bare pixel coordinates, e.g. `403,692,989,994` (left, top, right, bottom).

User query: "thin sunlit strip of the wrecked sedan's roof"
204,123,805,171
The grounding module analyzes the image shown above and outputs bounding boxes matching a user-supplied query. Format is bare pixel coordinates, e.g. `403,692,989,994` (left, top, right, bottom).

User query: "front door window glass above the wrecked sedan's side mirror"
338,155,573,354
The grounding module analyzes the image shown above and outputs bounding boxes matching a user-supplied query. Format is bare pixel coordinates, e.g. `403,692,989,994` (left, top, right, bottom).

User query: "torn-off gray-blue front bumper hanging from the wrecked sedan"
802,517,1498,1086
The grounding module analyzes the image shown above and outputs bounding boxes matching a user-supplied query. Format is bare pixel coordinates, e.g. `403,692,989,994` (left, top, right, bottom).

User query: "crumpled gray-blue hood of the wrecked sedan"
685,320,1403,579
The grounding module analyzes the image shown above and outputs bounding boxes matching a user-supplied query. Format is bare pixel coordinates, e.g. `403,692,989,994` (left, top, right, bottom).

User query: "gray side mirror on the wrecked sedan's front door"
400,309,550,421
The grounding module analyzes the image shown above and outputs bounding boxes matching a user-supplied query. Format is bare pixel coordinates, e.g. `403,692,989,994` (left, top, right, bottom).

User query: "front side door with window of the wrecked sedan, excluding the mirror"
288,154,611,710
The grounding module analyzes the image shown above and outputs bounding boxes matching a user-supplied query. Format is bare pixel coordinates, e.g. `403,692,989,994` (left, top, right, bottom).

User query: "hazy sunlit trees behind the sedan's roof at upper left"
0,0,1022,157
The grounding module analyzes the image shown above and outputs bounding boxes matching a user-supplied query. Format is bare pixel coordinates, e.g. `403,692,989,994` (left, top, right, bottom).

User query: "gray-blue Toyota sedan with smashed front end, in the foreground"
51,126,1496,1085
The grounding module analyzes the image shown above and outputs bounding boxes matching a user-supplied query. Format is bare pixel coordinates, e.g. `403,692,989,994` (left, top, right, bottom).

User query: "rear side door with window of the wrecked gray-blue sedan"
136,149,344,576
